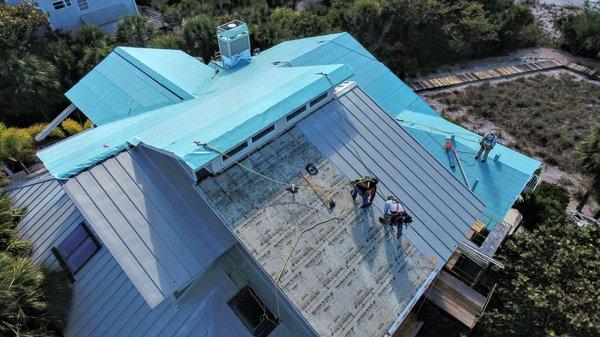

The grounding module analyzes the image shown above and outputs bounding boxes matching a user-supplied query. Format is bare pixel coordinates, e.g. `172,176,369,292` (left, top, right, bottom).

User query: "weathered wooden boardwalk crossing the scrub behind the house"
408,59,600,91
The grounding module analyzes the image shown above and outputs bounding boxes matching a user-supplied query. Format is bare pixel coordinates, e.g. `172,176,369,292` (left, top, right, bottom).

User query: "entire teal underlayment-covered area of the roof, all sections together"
39,33,541,226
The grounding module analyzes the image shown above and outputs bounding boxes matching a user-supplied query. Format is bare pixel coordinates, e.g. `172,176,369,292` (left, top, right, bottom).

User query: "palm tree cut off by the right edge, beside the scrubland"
575,123,600,211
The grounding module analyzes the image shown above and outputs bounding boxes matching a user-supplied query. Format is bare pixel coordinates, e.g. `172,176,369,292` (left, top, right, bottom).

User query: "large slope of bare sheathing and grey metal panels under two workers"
198,87,483,336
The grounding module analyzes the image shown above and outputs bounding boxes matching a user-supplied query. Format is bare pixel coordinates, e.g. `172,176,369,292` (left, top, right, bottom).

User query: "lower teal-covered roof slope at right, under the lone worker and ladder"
396,107,541,230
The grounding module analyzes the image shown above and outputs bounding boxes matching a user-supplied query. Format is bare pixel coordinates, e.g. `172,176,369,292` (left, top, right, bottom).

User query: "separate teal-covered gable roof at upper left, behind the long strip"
66,47,215,125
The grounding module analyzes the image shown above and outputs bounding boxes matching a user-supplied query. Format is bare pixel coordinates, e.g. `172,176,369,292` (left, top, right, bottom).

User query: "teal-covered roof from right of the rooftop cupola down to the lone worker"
272,33,541,229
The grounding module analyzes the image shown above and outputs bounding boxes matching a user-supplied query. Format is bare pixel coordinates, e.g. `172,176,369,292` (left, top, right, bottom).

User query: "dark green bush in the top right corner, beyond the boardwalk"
556,0,600,58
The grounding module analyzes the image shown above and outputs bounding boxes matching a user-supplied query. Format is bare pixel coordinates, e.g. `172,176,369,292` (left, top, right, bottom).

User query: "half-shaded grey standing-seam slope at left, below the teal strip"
64,147,233,307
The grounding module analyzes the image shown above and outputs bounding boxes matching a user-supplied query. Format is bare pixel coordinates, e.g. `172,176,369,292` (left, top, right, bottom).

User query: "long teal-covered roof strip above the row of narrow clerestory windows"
38,62,353,179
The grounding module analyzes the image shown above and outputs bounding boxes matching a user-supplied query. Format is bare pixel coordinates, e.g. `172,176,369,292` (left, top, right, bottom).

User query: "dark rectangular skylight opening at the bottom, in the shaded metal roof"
227,286,279,337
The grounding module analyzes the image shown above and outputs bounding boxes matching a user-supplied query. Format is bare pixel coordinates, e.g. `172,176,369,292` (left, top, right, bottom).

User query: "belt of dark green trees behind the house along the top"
0,0,539,127
